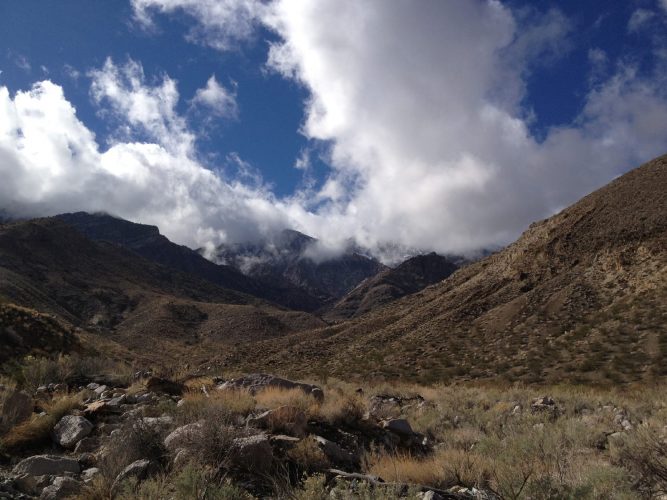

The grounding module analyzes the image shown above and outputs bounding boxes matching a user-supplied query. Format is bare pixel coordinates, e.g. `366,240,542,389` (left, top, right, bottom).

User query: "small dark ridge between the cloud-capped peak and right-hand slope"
324,252,459,321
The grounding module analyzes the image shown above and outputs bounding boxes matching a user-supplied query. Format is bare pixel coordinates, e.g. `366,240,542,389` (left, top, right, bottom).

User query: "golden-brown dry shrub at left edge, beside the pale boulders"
2,393,82,453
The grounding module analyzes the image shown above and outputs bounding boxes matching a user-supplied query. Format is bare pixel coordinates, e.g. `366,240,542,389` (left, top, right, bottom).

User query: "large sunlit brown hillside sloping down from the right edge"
222,156,667,385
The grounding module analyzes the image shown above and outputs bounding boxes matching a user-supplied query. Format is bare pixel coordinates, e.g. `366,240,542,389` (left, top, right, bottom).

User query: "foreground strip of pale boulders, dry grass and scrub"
0,364,667,499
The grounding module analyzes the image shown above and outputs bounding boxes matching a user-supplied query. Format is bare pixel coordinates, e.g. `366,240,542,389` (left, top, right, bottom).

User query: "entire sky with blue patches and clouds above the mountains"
0,0,667,262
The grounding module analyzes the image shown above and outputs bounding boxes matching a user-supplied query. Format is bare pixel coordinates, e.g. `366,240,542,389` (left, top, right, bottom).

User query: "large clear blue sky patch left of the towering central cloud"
0,0,316,195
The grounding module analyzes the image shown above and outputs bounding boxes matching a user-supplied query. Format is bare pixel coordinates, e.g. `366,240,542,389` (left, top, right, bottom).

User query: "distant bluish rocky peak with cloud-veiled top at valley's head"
217,229,386,306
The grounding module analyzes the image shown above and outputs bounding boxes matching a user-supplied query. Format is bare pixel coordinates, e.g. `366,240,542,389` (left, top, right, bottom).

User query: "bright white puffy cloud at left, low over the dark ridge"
0,60,287,247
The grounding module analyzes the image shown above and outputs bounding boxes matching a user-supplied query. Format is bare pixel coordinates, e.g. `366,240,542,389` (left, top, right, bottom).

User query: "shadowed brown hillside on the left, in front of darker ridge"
0,218,323,362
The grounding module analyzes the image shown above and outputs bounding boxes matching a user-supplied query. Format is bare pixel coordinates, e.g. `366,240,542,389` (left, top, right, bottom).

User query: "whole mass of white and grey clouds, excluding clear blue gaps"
0,0,667,257
